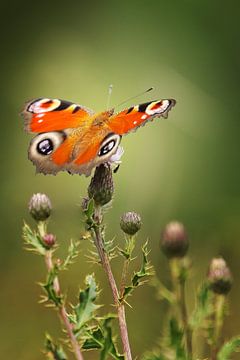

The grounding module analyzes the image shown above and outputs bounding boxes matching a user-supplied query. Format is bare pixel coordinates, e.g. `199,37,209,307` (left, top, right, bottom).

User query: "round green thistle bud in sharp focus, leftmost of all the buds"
28,193,52,221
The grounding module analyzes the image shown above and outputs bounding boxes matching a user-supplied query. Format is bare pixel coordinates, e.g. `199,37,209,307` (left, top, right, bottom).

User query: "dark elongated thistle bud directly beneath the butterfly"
88,163,114,206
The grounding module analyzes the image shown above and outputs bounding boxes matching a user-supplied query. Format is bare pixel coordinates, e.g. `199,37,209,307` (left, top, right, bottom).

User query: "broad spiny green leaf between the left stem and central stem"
69,275,100,336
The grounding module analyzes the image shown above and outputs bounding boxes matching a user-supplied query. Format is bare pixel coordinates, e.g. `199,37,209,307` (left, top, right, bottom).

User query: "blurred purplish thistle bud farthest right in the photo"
207,258,233,295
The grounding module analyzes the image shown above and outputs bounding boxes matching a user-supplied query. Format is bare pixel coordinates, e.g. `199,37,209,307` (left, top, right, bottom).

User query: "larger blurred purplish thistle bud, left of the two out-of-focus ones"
160,221,189,258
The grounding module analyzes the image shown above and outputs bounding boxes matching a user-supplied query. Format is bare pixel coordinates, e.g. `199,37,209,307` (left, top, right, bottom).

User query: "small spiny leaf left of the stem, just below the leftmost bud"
23,223,47,255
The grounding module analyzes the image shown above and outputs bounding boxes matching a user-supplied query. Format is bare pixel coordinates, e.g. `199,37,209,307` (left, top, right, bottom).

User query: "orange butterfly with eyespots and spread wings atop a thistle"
21,98,176,176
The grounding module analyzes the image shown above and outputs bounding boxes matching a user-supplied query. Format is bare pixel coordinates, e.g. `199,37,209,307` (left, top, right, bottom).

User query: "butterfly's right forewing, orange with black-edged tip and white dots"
108,99,176,135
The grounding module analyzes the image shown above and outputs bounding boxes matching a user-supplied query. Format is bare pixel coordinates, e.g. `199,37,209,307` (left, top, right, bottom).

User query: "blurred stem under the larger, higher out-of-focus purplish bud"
170,258,192,359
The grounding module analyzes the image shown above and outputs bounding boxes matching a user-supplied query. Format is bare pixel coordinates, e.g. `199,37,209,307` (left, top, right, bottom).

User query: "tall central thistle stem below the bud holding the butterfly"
93,206,132,360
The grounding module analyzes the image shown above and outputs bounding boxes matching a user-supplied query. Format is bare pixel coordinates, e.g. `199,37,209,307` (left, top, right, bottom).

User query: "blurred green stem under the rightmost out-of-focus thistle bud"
212,294,225,360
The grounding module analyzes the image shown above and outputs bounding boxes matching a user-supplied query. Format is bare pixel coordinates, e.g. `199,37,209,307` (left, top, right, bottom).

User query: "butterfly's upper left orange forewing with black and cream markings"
22,98,94,133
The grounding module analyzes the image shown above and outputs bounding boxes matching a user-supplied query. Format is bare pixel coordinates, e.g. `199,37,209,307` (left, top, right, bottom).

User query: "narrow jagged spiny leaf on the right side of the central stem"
119,242,153,301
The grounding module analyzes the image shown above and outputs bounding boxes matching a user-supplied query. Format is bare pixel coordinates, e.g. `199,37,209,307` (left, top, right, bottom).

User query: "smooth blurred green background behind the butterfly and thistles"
0,0,240,360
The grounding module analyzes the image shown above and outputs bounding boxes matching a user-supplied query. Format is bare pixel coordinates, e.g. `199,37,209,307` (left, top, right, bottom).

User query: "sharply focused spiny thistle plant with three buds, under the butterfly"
23,164,152,360
